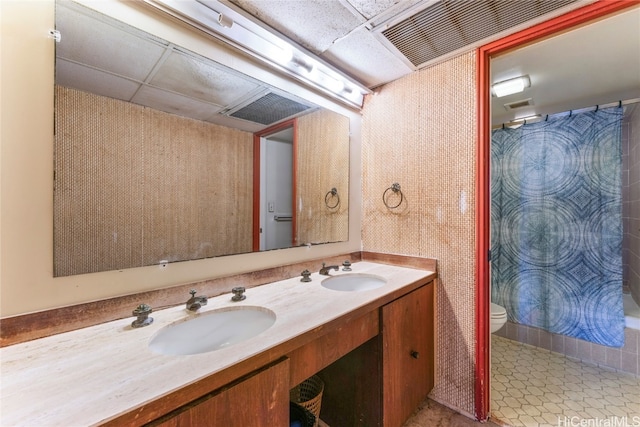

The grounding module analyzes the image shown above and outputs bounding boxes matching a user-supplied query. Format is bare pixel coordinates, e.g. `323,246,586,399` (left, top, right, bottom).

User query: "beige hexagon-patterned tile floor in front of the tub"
491,335,640,427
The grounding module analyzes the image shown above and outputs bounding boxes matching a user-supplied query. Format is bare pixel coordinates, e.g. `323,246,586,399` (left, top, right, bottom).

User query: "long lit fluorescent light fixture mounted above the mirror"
142,0,371,108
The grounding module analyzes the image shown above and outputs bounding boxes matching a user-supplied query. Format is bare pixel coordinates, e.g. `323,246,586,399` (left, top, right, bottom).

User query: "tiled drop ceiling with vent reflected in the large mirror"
56,0,317,132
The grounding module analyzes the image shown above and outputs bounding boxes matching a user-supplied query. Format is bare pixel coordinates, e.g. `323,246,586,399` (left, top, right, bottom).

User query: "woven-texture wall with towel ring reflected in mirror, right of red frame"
296,110,349,244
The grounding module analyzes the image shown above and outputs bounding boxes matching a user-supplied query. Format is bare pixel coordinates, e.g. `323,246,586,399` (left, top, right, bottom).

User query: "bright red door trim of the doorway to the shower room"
475,0,640,421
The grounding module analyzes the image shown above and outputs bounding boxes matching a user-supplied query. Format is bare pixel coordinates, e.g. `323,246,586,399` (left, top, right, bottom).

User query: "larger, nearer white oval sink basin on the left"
149,306,276,356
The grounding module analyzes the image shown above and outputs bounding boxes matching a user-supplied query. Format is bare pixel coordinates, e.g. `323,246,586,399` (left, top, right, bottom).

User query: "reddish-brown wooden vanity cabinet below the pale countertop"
144,282,434,427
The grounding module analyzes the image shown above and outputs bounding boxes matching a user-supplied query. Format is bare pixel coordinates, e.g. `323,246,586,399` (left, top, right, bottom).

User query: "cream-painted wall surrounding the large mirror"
0,0,362,317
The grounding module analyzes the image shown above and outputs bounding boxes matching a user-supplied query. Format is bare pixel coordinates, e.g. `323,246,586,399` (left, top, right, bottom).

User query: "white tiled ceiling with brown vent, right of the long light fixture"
226,0,584,88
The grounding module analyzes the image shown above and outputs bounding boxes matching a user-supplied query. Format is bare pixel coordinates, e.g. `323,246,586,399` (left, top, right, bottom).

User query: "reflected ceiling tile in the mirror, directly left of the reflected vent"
149,50,260,106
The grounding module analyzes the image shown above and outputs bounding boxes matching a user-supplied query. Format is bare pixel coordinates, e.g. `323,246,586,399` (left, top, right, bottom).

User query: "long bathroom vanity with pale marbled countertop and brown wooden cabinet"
1,262,436,426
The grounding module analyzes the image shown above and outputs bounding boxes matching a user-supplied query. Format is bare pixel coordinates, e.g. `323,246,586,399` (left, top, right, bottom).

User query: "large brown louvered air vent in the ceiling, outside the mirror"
382,0,577,68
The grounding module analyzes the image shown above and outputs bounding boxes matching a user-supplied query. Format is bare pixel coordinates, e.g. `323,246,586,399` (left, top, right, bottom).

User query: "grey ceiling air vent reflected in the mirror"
229,92,312,125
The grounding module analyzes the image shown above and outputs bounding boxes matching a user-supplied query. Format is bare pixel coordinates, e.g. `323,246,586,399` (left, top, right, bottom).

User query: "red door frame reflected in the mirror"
253,118,298,252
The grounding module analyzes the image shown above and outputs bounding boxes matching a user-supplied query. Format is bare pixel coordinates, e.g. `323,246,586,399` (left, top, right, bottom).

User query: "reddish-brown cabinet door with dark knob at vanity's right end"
382,282,434,427
